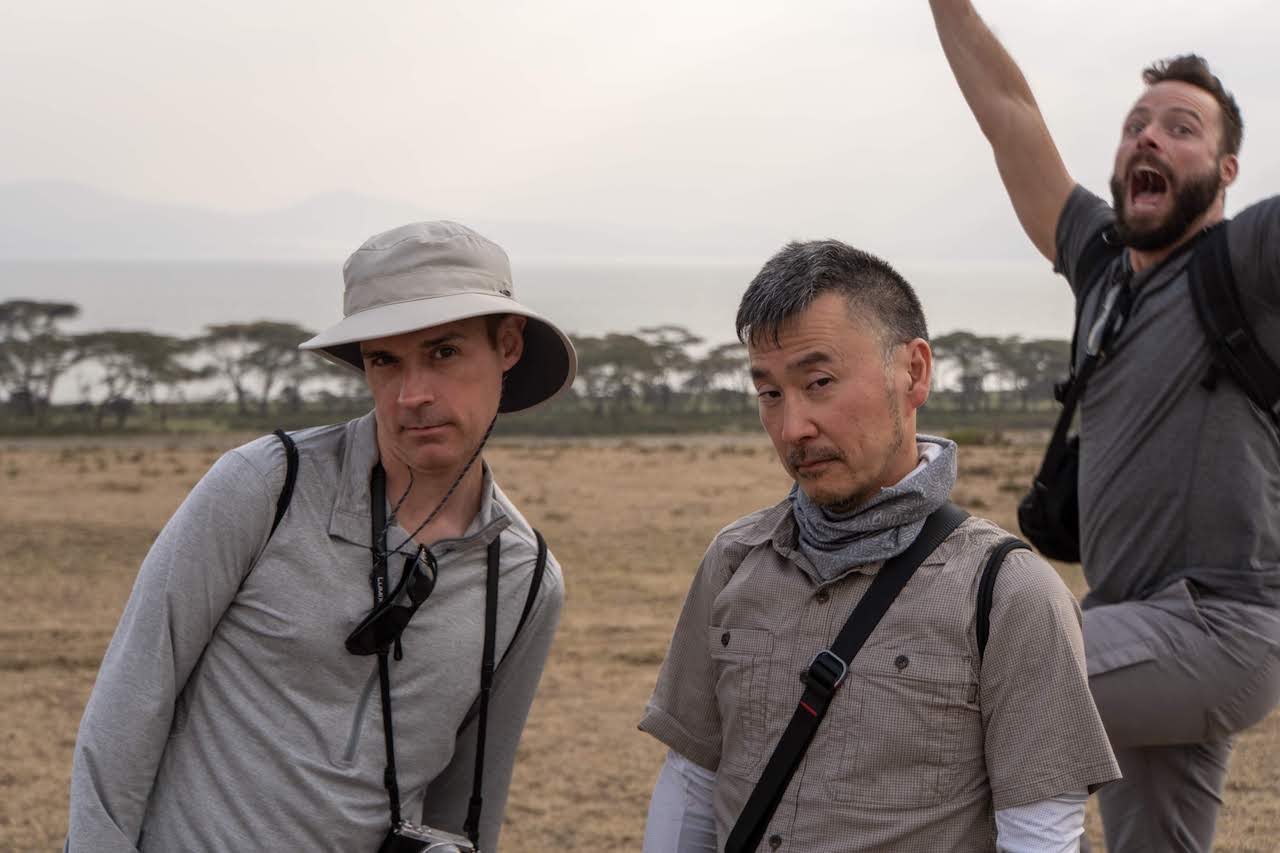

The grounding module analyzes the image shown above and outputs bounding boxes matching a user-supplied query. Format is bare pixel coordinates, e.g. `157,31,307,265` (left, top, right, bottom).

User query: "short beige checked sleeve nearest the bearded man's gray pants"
979,551,1120,809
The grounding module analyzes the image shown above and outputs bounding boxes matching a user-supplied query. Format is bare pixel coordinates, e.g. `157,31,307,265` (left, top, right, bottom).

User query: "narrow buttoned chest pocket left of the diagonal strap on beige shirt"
707,625,773,775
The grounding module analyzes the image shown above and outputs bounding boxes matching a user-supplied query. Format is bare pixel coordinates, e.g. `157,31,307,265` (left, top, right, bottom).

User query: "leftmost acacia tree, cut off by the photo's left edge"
0,300,79,427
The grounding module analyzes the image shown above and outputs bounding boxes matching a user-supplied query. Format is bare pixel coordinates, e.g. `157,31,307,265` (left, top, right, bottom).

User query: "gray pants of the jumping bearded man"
1084,583,1280,853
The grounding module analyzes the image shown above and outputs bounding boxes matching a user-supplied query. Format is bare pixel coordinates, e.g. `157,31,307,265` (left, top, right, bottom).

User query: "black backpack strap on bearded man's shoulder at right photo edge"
1189,222,1280,427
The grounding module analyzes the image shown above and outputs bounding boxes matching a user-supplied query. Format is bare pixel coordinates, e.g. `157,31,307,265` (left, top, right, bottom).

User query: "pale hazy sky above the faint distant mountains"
0,0,1280,263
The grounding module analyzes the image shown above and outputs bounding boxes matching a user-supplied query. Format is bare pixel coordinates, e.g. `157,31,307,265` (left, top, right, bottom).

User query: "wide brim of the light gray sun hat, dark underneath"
298,292,577,414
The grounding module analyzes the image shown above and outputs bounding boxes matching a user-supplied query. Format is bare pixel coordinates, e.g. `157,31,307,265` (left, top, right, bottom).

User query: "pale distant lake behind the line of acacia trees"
0,257,1071,343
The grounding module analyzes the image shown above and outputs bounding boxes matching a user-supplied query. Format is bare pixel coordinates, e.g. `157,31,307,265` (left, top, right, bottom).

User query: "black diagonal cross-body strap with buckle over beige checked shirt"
724,502,969,853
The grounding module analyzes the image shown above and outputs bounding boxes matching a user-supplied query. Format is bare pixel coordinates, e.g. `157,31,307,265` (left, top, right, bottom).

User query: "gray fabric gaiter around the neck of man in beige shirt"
791,435,956,581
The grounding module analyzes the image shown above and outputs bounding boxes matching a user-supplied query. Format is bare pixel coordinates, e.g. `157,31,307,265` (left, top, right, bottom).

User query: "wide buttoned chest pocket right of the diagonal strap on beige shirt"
814,648,983,807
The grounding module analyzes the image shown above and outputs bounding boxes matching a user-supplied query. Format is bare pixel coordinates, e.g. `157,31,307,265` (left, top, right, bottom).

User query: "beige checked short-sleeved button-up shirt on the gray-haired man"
640,501,1120,853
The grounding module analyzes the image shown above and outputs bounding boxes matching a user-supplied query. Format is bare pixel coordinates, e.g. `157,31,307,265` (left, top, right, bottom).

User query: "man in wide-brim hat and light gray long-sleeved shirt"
68,222,576,853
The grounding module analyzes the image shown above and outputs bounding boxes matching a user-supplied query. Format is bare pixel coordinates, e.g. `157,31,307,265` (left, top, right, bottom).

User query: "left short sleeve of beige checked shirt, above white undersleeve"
640,538,731,772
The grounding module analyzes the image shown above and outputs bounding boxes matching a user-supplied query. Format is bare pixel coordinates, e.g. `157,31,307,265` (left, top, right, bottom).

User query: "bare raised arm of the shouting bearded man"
929,0,1075,261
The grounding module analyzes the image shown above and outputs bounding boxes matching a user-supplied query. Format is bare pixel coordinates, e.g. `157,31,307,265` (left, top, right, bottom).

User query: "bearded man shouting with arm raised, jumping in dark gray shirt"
931,0,1280,853
